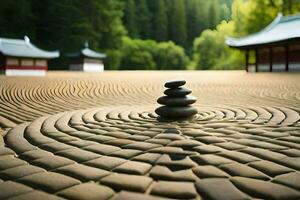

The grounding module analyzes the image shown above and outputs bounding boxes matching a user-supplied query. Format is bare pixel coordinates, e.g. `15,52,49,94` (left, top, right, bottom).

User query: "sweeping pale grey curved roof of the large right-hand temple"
226,14,300,48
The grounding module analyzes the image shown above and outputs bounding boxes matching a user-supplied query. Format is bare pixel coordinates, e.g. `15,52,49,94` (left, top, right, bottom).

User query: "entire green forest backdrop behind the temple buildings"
0,0,300,70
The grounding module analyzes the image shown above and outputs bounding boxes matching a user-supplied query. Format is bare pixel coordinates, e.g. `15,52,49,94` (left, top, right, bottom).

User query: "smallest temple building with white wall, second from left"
66,42,106,72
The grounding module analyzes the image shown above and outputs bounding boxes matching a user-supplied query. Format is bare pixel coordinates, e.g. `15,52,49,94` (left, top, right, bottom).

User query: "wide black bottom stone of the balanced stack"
155,106,198,118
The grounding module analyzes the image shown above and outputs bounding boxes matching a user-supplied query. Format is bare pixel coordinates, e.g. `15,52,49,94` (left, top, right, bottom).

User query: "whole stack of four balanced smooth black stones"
155,80,198,118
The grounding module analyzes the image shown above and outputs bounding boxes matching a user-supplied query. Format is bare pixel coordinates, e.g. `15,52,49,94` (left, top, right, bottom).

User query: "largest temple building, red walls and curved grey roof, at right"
226,14,300,72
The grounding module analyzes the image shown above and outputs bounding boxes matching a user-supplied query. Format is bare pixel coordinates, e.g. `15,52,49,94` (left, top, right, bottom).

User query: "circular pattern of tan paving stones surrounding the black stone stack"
0,106,300,199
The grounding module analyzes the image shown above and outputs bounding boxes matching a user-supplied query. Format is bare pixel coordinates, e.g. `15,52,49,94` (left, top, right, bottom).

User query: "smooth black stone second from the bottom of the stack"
157,95,197,106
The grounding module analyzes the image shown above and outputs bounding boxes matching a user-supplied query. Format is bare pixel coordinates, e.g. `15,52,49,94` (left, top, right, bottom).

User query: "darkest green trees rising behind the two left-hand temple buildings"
0,0,126,69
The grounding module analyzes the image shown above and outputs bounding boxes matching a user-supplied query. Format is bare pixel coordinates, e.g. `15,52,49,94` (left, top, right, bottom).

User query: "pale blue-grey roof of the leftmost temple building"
0,38,60,59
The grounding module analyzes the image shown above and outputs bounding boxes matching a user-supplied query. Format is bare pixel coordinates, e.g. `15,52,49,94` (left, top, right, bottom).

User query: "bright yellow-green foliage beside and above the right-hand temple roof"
192,0,300,69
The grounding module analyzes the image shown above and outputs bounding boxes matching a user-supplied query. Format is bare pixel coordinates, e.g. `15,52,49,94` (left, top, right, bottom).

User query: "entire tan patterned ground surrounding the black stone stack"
0,71,300,200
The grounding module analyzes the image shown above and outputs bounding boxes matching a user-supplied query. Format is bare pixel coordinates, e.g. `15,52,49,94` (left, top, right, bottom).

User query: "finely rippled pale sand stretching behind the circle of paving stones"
0,71,300,128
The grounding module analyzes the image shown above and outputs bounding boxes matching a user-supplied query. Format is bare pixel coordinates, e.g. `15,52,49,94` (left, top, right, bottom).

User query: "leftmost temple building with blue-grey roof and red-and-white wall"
0,36,59,76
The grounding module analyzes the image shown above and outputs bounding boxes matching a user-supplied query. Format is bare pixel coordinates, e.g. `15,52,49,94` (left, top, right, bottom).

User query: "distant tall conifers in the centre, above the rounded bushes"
123,0,232,50
